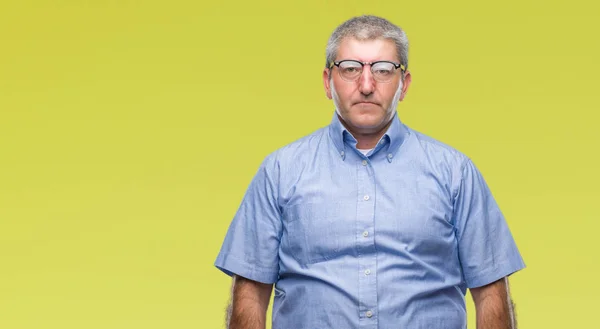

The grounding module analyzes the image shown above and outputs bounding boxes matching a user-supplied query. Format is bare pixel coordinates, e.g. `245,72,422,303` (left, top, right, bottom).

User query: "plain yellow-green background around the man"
0,0,600,329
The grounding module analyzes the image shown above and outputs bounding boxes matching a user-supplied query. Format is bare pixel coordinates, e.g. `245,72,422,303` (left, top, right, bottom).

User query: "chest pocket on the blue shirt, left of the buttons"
282,203,356,265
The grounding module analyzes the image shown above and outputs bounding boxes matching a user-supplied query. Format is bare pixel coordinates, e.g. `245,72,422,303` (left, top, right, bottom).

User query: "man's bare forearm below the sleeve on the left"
226,275,273,329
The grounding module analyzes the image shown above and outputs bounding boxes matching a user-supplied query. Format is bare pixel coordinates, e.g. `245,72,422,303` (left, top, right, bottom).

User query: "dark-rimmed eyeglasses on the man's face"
329,60,406,82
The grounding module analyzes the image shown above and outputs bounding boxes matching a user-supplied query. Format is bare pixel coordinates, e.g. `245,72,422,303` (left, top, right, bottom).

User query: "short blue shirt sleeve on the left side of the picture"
214,155,282,284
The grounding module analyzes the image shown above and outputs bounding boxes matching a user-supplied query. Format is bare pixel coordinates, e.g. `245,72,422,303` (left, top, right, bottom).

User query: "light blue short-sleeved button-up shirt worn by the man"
215,113,525,329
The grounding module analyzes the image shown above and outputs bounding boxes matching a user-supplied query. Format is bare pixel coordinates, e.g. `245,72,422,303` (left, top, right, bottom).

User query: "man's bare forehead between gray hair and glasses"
336,38,398,62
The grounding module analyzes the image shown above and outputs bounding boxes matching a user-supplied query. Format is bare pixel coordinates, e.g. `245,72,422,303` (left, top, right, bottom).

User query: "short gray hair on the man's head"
325,15,408,68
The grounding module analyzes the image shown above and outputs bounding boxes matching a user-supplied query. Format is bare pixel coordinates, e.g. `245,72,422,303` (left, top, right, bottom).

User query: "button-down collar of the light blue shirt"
329,112,409,162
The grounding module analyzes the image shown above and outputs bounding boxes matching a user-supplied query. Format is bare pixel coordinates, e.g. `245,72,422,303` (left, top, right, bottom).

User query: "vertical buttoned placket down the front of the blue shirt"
356,157,378,329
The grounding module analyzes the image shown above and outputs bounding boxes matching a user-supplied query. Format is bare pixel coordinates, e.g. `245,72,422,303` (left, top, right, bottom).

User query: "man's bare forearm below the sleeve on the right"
470,277,517,329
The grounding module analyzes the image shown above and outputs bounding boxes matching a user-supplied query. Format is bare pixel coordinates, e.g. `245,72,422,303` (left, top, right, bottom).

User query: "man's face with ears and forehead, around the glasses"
323,38,410,134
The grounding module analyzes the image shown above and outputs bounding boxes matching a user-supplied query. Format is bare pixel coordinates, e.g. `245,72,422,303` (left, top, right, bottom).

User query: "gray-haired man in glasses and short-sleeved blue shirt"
215,16,525,329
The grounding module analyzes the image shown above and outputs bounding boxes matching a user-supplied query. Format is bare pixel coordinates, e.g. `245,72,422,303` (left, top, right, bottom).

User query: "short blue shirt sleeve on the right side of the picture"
454,160,525,288
